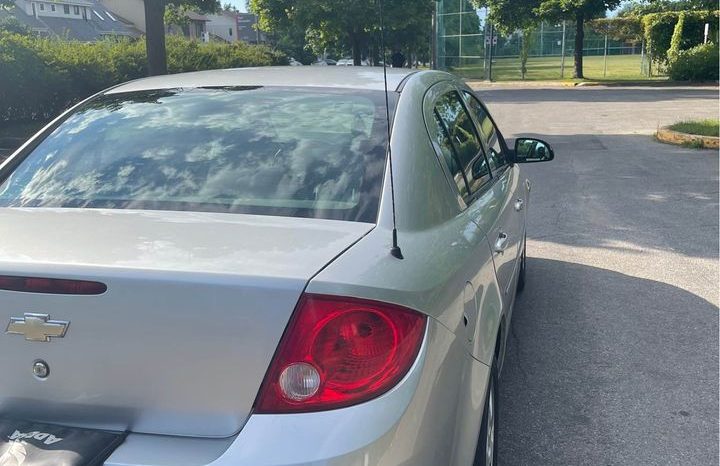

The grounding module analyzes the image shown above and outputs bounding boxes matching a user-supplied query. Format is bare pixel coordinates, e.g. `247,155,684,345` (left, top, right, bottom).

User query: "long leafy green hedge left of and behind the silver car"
0,31,287,124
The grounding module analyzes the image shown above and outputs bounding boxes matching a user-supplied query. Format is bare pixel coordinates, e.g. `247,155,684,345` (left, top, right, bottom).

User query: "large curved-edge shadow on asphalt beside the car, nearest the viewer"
499,257,718,466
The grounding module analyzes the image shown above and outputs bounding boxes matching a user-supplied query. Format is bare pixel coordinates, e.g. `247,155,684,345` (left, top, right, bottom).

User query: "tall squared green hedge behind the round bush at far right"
642,10,720,65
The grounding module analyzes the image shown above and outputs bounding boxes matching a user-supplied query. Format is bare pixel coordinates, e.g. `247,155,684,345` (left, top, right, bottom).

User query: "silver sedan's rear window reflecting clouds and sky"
0,87,394,222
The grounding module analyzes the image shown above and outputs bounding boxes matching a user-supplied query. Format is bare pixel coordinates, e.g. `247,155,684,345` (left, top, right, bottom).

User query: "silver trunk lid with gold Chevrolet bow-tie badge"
0,209,373,437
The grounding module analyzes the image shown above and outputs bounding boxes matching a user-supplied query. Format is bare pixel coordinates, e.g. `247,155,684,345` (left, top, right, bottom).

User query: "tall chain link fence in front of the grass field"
435,0,650,81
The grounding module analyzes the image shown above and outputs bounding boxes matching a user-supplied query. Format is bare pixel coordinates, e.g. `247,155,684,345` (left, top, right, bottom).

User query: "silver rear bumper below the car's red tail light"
105,319,487,466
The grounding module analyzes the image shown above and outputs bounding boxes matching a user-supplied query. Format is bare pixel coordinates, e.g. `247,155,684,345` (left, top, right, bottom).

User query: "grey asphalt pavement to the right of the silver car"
480,88,719,466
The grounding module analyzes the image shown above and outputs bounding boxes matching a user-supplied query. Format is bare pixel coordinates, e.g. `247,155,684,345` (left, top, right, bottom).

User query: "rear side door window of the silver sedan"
434,91,491,197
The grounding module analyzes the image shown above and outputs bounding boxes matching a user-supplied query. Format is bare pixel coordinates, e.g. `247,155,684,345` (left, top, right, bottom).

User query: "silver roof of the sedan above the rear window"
106,66,417,94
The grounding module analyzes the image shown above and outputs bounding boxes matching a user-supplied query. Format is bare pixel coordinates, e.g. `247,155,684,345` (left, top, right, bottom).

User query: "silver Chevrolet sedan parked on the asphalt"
0,67,553,466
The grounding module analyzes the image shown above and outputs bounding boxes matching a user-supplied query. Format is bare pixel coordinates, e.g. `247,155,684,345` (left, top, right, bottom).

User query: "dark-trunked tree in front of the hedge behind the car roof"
141,0,220,76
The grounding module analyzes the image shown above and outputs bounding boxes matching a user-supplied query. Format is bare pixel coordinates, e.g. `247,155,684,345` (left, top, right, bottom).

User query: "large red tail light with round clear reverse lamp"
255,295,426,413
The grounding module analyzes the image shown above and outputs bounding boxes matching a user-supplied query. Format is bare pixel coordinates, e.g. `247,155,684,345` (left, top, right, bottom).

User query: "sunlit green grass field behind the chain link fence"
452,55,663,81
